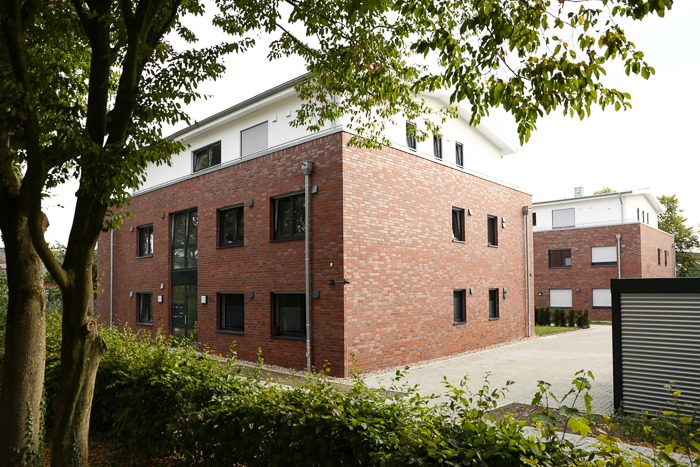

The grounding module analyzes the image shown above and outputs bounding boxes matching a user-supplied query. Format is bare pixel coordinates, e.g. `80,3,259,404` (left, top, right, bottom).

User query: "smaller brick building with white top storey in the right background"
532,189,675,321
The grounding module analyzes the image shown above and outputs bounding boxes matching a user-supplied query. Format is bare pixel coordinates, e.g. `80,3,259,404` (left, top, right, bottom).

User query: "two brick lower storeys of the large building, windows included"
98,77,534,376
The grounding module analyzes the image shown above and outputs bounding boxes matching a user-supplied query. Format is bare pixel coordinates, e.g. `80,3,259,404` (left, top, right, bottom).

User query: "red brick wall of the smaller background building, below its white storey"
534,223,675,321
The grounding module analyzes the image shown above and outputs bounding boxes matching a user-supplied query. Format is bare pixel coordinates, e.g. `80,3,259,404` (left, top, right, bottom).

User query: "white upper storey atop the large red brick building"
138,77,515,192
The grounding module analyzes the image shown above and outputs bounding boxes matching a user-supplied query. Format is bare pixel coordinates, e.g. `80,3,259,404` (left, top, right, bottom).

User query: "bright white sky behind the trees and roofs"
32,0,700,249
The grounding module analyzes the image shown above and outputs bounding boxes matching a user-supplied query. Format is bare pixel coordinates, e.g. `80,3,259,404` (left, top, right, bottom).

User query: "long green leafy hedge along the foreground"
37,312,699,466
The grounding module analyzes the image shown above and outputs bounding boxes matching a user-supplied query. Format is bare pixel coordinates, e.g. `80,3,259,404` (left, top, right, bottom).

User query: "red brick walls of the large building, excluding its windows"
98,133,534,376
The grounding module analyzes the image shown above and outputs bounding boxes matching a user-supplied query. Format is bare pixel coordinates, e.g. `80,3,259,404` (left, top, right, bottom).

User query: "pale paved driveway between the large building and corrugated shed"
360,325,613,414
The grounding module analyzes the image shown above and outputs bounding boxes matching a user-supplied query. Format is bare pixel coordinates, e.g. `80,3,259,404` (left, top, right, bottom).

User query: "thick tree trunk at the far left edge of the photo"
0,207,46,465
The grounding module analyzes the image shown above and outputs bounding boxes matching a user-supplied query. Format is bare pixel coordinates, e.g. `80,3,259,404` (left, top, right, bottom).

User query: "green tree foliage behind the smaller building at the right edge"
659,195,700,277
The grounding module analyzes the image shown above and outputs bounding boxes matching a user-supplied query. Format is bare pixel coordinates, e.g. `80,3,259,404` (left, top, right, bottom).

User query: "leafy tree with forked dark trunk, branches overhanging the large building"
0,0,672,464
